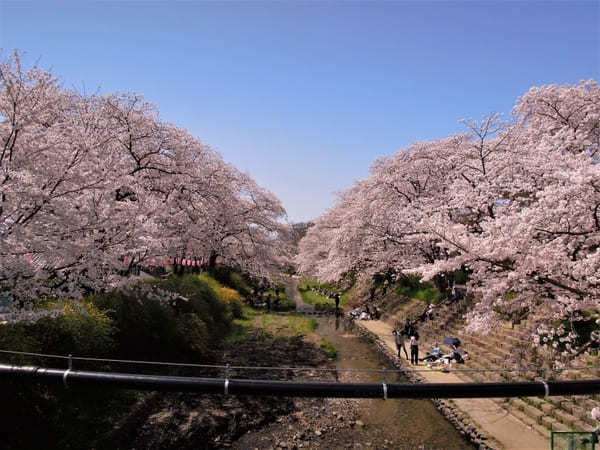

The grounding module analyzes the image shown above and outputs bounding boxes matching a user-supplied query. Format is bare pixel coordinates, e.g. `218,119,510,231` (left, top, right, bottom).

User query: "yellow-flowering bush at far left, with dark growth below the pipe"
0,301,135,448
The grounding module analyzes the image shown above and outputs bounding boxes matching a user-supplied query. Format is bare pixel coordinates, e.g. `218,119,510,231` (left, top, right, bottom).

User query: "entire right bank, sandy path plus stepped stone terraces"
359,294,600,449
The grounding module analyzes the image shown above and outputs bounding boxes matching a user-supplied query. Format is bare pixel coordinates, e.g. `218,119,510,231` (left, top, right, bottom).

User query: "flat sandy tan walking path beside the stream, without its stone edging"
358,320,550,450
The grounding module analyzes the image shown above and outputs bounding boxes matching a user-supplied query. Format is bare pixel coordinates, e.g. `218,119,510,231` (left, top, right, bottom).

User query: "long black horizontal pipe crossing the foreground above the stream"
0,364,600,398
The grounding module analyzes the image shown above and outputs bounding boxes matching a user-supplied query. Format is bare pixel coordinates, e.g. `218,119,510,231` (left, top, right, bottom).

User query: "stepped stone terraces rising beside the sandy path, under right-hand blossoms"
412,303,600,439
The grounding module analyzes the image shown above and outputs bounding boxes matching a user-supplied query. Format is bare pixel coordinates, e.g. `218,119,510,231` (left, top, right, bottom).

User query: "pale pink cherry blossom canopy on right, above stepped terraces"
298,81,600,344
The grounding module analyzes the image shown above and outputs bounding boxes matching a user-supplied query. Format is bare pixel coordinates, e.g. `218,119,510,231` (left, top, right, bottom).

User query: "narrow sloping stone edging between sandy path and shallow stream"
354,322,496,450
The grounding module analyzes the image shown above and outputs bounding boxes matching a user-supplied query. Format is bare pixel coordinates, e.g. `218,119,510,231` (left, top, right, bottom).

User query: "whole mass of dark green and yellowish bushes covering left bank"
0,274,255,448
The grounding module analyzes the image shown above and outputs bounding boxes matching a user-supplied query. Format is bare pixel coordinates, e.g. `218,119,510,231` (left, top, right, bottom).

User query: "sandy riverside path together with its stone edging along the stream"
356,321,550,450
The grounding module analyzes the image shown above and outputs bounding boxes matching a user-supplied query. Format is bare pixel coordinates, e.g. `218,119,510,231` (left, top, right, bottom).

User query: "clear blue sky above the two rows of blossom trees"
0,0,600,221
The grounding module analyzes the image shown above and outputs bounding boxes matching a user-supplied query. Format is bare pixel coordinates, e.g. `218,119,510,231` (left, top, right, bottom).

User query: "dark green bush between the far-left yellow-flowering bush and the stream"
91,274,232,360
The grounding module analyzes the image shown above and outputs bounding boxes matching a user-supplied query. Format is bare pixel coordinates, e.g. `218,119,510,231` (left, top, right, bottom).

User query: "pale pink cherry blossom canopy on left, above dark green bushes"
0,53,290,296
